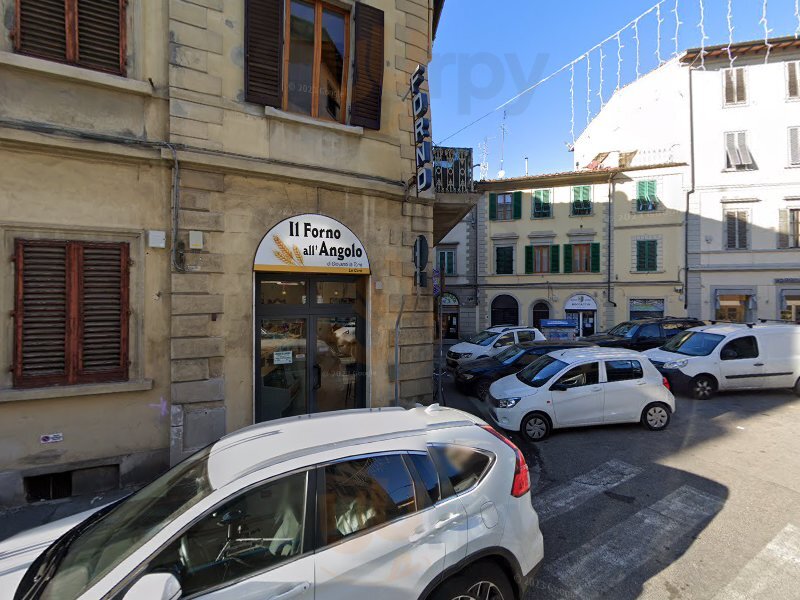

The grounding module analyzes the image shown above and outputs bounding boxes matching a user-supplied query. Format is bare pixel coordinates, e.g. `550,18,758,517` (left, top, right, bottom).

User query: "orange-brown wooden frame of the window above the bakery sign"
281,0,353,124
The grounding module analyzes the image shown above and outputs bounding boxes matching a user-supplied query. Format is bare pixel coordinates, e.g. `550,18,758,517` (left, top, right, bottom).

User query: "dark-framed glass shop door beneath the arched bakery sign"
255,273,366,422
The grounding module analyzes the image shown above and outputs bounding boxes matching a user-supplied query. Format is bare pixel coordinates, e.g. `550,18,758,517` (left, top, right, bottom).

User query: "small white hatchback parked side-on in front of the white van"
489,348,675,442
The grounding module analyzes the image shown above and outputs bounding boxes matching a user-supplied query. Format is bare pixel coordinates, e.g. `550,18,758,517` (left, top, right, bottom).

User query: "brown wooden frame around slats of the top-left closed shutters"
12,0,128,77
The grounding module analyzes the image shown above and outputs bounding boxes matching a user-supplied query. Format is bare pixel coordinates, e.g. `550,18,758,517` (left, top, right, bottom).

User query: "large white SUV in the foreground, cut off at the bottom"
0,405,543,600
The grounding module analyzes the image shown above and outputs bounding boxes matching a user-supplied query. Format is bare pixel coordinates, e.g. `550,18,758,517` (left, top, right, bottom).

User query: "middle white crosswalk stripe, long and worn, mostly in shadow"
545,485,723,600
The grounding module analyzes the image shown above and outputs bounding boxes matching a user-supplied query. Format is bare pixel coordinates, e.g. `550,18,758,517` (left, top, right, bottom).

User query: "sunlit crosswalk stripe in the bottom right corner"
714,524,800,600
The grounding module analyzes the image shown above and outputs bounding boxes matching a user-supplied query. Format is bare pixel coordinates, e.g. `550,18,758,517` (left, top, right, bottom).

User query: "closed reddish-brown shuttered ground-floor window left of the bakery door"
13,239,129,387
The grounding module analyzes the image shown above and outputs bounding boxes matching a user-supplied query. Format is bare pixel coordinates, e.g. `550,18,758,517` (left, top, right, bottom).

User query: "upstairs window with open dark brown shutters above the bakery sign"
245,0,384,129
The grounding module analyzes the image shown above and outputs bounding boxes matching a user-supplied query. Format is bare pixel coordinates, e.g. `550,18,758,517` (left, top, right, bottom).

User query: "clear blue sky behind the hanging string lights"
429,0,800,179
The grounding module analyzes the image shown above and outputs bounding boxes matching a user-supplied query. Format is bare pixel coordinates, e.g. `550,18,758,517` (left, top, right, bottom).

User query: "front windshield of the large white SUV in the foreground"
40,447,213,600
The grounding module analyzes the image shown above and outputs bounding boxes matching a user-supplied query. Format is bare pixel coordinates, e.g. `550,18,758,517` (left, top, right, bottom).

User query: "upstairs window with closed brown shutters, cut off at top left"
14,0,127,75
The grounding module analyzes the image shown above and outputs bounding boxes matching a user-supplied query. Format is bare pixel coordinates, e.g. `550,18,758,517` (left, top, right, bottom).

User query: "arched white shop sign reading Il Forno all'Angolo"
253,214,370,274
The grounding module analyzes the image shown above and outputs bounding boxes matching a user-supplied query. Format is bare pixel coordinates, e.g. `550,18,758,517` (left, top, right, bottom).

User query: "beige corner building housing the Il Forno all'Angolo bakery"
0,0,456,506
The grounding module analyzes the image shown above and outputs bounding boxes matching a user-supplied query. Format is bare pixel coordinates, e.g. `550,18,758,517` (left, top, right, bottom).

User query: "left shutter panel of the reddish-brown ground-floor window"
14,240,68,387
